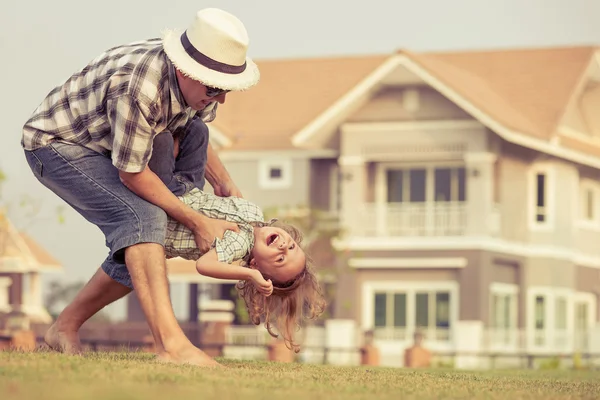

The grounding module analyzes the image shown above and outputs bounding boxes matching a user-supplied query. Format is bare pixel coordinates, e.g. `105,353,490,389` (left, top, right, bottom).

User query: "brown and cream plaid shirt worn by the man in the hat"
21,39,217,172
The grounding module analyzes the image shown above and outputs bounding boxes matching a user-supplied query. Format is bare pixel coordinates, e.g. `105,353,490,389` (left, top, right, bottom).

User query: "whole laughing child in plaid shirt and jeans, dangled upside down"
149,118,325,352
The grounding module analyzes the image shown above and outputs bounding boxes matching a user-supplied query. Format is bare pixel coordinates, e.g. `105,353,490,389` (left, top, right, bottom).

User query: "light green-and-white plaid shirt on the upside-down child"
165,188,264,264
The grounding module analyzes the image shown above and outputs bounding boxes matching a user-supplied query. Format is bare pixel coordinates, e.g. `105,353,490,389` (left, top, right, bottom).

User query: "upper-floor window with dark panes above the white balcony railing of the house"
386,167,466,203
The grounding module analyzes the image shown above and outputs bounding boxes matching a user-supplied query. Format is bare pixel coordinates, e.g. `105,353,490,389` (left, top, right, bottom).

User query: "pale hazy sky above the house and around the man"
0,0,600,319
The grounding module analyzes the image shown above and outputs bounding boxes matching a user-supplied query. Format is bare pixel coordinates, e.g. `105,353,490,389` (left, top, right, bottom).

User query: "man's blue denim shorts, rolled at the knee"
25,142,167,288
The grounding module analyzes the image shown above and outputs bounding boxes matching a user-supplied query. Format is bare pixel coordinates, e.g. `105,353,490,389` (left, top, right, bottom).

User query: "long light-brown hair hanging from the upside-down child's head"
236,220,326,353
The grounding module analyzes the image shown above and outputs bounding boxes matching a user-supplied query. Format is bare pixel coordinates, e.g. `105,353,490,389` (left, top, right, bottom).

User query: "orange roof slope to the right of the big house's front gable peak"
406,47,596,139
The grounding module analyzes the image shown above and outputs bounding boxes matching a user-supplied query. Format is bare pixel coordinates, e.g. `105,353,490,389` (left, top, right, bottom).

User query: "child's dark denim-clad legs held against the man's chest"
148,118,208,196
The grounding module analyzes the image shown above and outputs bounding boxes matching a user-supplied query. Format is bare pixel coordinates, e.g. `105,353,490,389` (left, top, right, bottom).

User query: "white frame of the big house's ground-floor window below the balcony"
361,281,459,341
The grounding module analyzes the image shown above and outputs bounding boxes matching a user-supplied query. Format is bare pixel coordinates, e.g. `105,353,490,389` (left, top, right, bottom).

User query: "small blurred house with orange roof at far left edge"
0,210,63,328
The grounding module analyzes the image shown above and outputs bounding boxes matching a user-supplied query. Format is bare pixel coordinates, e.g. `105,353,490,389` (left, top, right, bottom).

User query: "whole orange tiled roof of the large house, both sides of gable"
212,46,599,159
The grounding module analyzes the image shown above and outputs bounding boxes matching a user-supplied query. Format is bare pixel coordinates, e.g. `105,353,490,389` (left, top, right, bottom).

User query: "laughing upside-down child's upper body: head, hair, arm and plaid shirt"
165,188,325,352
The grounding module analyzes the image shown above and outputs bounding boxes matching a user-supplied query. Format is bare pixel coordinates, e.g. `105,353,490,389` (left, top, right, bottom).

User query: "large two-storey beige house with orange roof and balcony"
156,47,600,363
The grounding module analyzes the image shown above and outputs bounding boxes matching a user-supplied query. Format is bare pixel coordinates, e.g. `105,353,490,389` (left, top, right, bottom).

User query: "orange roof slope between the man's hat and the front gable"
211,55,389,150
